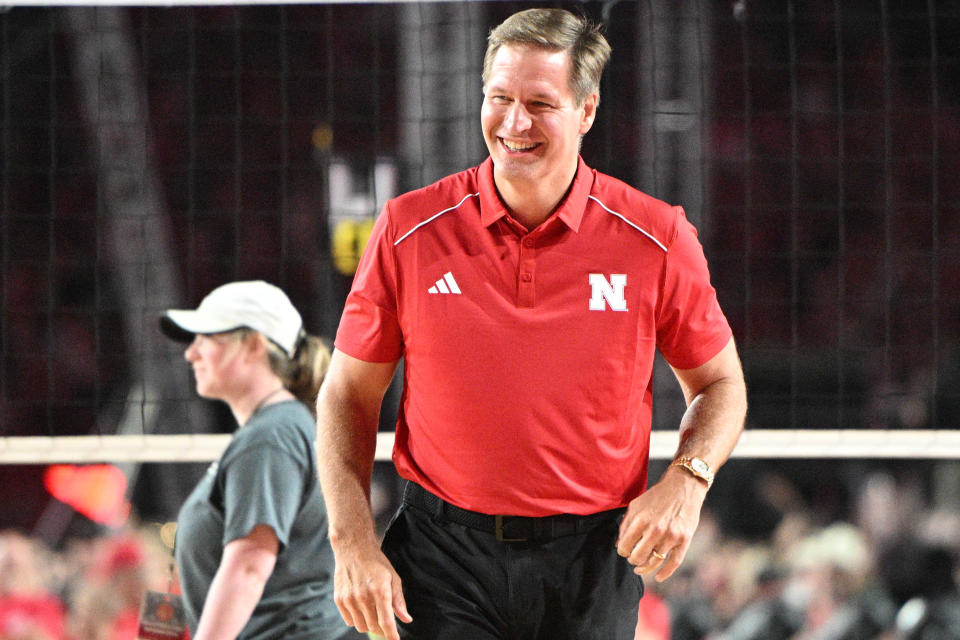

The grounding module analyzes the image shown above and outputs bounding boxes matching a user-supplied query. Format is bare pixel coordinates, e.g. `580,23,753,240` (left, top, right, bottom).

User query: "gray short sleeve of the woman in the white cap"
220,446,304,548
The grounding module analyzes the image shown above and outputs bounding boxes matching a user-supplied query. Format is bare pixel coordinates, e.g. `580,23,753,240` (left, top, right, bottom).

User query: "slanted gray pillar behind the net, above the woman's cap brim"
56,6,195,528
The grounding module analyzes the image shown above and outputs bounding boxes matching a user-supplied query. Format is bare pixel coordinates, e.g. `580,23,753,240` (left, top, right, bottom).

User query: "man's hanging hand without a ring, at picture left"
333,546,413,640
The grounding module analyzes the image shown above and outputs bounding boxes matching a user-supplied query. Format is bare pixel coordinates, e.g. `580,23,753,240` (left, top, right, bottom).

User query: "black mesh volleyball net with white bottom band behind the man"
0,0,960,528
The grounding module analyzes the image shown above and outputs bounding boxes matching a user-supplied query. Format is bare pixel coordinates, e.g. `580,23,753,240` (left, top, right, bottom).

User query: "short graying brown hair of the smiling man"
483,8,610,106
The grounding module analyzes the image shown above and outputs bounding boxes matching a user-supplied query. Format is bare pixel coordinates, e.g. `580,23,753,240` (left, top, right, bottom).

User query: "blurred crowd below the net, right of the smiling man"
648,464,960,640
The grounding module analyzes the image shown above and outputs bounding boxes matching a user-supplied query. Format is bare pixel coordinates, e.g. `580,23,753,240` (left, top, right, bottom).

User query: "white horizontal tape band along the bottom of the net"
0,429,960,464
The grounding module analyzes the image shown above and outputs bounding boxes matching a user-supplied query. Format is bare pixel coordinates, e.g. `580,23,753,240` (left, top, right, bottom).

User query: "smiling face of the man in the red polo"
480,46,597,190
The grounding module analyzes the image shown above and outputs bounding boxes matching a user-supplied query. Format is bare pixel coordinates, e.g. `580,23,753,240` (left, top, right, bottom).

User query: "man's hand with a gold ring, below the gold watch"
617,467,707,582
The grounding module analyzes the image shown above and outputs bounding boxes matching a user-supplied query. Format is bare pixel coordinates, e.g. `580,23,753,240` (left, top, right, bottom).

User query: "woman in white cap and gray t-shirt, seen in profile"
160,281,362,640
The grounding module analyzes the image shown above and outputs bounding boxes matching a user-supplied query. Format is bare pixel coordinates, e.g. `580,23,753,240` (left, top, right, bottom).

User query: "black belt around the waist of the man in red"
403,482,625,542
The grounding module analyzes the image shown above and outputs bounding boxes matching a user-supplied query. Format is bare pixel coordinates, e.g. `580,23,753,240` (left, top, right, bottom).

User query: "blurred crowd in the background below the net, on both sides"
0,464,960,640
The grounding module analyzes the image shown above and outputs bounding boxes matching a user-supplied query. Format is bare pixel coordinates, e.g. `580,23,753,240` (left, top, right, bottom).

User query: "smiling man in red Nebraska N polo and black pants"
317,9,746,640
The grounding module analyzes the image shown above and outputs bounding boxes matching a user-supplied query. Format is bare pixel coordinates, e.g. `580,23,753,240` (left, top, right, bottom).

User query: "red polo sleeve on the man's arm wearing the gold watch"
657,207,732,369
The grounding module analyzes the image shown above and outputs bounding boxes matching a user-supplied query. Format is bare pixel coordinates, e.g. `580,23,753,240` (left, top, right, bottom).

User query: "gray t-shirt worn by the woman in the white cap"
176,400,352,640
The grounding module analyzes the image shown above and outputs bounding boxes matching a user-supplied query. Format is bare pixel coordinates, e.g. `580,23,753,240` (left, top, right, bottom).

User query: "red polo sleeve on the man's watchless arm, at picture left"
334,203,403,362
